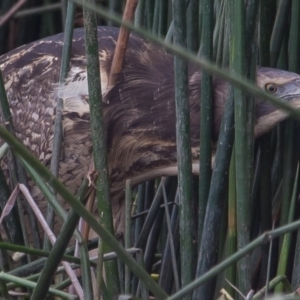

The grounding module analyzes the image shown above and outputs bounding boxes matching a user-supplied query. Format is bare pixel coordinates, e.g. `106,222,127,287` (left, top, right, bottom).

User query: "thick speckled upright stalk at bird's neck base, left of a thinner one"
173,0,195,299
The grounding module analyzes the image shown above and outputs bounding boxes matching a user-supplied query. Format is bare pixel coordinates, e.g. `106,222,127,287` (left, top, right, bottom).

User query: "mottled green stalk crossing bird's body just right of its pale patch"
83,0,119,298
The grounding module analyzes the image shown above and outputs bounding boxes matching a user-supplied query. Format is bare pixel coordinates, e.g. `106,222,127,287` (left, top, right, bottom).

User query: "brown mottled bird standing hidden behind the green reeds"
0,27,300,237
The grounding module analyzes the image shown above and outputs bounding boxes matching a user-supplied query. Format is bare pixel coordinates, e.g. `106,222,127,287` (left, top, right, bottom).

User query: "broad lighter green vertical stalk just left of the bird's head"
231,0,251,294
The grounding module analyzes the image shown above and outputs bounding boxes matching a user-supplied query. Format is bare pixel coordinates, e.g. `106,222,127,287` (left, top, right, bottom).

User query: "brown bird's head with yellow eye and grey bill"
255,67,300,137
